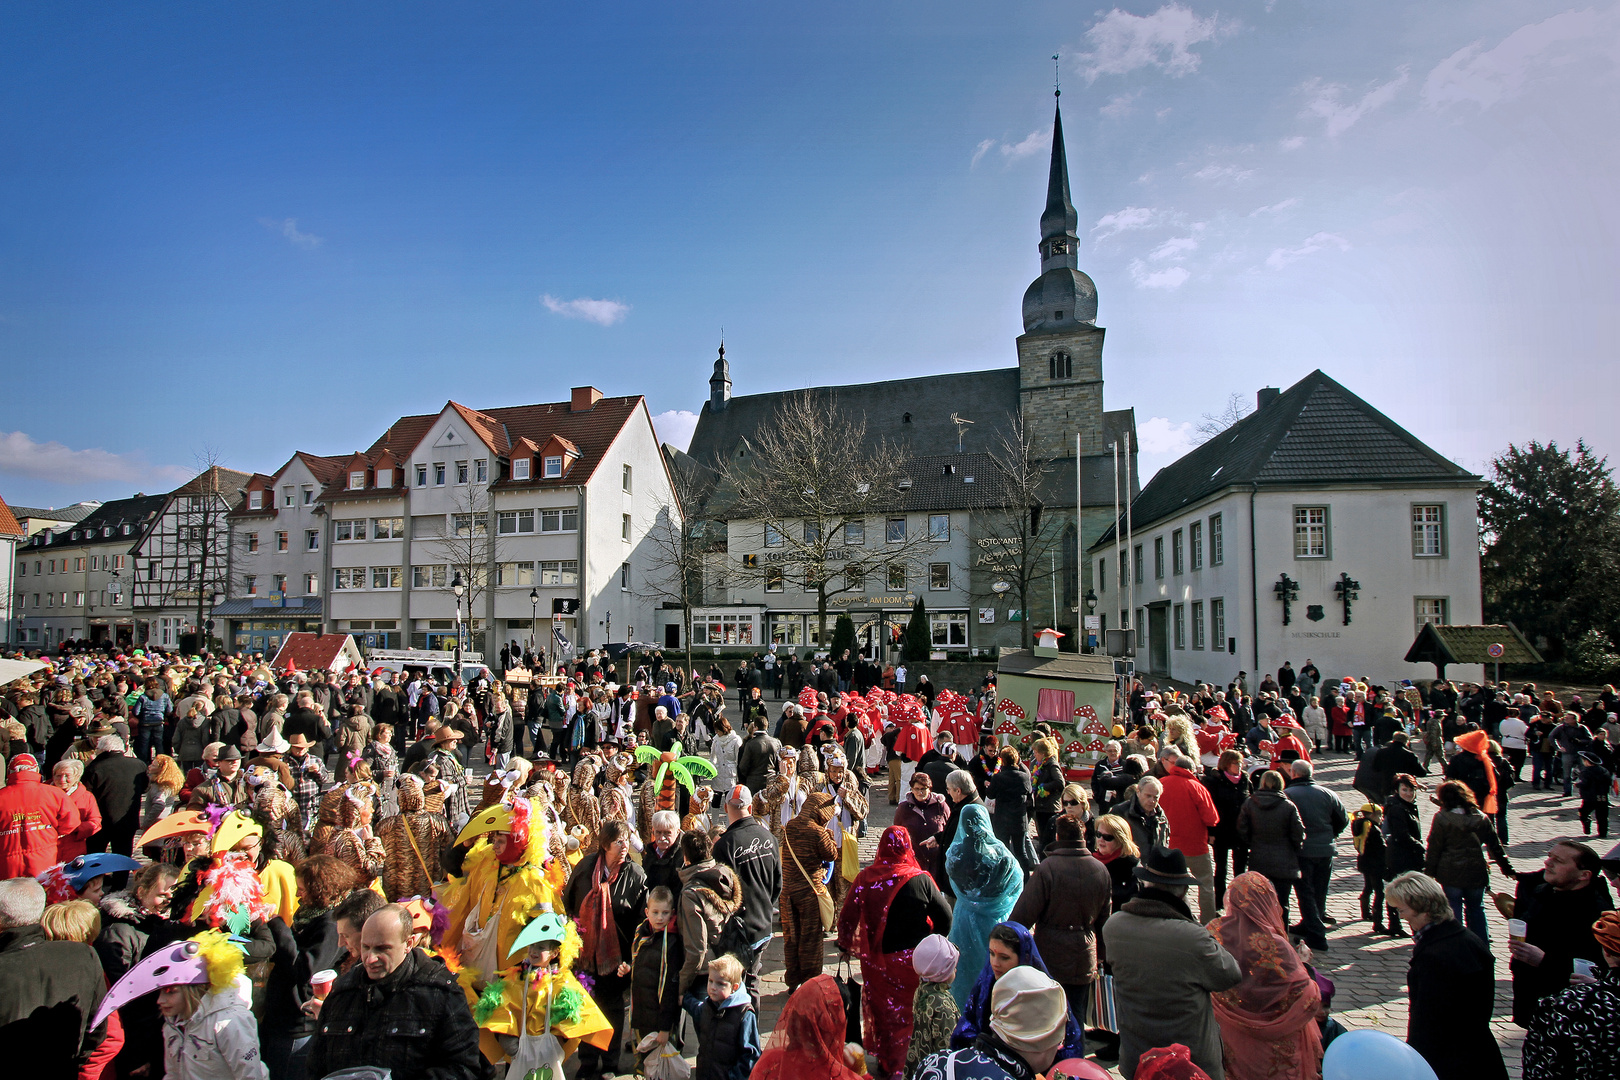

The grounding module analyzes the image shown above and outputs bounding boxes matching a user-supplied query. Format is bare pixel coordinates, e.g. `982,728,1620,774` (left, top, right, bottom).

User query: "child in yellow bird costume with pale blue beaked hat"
473,908,612,1080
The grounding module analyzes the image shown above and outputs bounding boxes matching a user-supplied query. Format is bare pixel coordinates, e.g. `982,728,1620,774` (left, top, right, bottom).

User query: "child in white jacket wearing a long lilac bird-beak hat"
91,929,269,1080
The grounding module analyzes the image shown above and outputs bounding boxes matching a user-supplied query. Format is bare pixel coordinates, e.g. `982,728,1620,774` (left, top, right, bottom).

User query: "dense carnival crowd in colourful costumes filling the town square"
0,648,1620,1080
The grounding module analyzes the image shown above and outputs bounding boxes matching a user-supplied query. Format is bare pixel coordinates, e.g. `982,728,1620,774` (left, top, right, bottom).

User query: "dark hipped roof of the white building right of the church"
1087,369,1482,551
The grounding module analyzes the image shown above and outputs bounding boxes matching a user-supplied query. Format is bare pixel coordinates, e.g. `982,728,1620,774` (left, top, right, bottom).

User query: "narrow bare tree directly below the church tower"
970,415,1072,649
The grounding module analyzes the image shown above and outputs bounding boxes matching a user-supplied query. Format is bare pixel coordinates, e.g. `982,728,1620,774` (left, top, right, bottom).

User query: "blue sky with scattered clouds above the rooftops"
0,0,1620,505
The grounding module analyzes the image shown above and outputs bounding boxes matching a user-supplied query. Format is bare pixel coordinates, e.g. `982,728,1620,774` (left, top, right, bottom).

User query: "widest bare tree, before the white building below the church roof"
714,392,952,643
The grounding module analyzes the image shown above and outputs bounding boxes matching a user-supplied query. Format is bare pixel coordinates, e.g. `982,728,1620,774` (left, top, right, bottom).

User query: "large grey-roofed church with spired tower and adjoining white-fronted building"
689,93,1137,654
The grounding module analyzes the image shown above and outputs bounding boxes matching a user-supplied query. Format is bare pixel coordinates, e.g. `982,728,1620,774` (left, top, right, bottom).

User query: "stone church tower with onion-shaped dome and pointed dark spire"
1017,93,1103,458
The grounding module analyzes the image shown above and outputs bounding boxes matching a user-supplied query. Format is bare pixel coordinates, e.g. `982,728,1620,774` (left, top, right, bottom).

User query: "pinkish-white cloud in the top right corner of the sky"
1422,8,1617,108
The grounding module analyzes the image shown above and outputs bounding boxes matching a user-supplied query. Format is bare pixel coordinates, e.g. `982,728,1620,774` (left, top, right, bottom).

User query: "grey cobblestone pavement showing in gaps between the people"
738,753,1609,1075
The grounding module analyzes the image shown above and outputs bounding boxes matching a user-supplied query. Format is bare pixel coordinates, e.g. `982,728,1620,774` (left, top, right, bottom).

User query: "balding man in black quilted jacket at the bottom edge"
305,904,484,1080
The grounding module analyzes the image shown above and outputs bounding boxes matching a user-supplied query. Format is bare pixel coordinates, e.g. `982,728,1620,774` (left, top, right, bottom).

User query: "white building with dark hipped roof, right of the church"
1087,371,1482,687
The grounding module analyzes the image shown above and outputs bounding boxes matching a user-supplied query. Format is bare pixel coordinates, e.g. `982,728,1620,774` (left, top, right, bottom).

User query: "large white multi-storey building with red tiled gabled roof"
318,387,680,656
